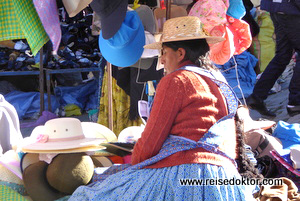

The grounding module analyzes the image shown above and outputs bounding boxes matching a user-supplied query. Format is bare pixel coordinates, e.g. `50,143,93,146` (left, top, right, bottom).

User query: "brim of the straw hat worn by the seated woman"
144,36,225,49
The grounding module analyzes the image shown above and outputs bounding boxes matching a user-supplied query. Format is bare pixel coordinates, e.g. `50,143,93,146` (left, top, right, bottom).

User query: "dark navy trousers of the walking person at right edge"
253,13,300,105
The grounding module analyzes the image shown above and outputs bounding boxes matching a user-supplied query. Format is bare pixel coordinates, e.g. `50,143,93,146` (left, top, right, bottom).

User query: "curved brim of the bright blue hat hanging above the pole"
99,11,145,67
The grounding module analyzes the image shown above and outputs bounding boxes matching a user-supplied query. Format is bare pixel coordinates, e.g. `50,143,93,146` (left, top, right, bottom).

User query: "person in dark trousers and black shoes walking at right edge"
246,0,300,116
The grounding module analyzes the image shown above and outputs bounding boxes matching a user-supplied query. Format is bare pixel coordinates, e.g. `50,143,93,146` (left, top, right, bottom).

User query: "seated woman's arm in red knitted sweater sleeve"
131,76,184,165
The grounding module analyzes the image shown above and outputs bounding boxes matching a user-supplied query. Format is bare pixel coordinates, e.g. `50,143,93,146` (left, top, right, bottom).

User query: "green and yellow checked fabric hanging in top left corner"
0,0,49,55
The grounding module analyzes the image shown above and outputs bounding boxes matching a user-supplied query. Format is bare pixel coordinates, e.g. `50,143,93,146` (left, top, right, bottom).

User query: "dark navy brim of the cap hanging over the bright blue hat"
100,0,128,39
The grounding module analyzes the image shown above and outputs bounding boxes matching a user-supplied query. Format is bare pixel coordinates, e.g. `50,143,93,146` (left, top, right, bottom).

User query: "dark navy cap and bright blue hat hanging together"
91,0,145,67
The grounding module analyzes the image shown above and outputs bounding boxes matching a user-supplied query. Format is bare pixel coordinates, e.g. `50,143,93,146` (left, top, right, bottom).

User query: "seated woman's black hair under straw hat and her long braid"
163,39,263,179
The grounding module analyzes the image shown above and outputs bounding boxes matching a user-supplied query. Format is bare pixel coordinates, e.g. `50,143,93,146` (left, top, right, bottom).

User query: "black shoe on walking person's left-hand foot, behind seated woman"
246,94,276,117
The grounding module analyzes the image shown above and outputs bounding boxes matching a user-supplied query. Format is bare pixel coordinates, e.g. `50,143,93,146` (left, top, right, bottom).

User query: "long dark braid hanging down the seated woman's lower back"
235,110,263,179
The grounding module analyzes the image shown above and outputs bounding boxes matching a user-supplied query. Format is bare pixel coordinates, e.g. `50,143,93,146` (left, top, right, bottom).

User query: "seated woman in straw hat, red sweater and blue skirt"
70,16,257,200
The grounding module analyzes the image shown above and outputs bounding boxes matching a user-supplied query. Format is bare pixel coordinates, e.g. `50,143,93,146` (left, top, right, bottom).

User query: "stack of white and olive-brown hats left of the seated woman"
15,118,117,201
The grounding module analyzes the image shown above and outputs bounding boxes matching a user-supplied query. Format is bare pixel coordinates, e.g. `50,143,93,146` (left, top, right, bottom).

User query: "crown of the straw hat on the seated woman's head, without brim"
162,16,207,41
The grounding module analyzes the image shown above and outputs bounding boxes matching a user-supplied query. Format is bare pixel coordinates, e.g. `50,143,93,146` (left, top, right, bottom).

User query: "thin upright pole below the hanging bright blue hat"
107,62,114,131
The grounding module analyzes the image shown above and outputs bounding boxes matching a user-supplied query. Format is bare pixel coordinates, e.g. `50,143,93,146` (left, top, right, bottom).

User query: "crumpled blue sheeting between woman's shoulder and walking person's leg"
216,51,258,99
